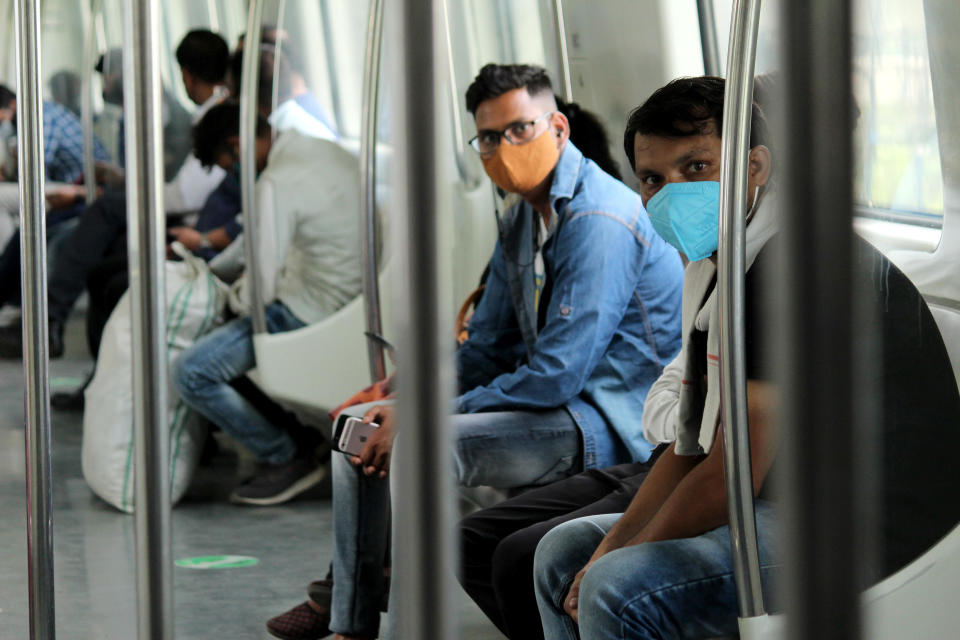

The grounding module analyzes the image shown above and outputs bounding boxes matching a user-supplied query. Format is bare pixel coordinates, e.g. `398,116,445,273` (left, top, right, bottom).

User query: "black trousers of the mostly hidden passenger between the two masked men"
459,449,662,640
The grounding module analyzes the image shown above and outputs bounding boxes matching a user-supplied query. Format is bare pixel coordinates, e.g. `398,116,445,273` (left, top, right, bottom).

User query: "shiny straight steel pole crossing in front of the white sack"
123,0,173,640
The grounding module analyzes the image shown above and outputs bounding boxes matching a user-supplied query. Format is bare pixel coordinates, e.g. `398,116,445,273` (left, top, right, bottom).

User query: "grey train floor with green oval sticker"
0,319,503,640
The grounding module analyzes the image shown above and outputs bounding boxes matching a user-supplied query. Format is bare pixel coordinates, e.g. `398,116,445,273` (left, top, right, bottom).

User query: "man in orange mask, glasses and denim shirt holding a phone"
316,65,683,638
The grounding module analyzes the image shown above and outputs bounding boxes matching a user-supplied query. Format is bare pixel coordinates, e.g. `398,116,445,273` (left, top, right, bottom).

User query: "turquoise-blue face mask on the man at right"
647,181,720,262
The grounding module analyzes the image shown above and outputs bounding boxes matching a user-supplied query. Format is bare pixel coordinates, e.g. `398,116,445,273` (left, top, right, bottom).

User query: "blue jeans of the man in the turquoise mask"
534,500,779,640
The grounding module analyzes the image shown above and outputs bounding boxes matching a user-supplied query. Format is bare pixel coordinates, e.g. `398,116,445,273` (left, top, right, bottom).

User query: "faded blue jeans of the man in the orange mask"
330,409,583,638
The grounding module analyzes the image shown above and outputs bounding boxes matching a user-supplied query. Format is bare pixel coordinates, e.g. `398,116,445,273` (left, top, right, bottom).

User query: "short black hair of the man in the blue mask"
623,76,769,168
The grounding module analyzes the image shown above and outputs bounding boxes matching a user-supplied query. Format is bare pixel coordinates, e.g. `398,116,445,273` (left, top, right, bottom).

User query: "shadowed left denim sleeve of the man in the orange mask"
457,242,523,392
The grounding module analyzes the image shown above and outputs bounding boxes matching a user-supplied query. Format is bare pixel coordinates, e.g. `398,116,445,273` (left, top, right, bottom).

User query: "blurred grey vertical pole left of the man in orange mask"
391,0,457,640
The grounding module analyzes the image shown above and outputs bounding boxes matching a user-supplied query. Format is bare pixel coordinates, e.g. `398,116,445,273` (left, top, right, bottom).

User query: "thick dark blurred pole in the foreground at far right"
778,0,860,640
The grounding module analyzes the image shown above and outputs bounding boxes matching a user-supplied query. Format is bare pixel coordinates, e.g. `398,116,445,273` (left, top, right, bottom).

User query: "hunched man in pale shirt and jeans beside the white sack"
171,104,361,505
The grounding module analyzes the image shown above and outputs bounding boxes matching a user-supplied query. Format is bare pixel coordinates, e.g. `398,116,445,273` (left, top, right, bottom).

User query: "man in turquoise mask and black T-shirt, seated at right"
532,78,960,640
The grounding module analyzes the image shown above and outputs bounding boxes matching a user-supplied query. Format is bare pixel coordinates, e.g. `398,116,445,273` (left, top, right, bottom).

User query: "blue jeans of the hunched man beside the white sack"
170,302,304,465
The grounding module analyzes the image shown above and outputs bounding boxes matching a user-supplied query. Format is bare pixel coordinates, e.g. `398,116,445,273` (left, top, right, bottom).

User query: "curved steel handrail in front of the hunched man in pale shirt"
240,0,266,333
